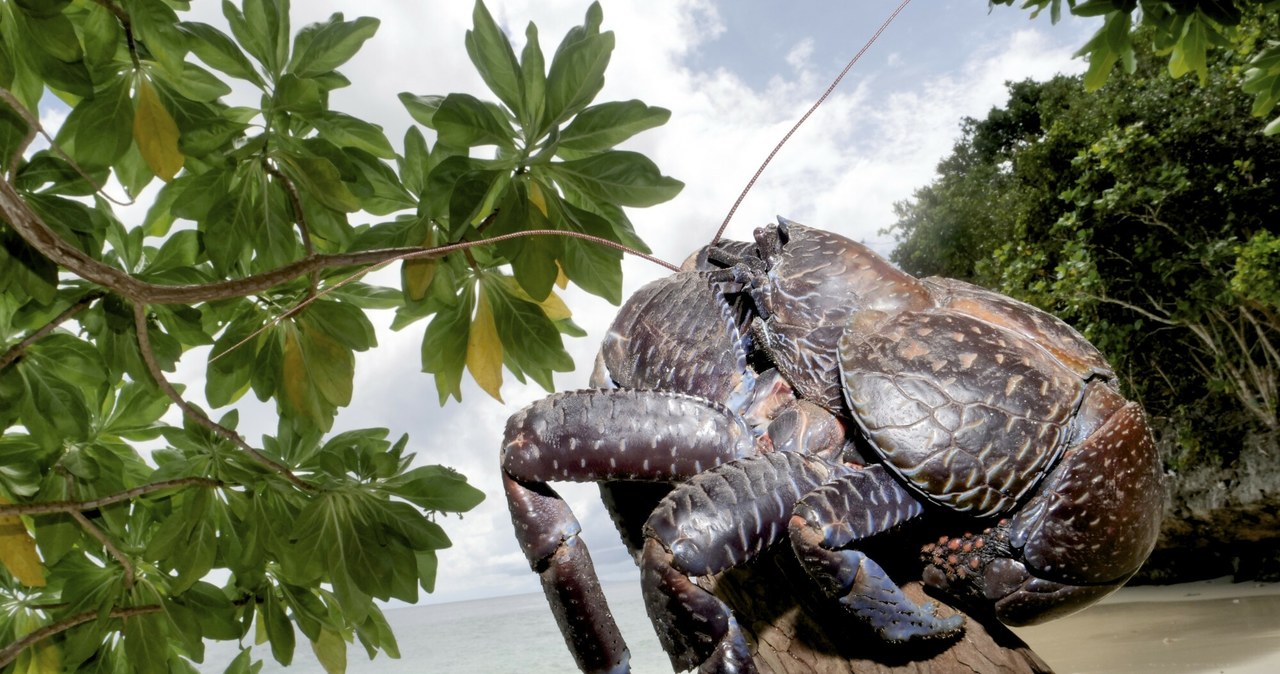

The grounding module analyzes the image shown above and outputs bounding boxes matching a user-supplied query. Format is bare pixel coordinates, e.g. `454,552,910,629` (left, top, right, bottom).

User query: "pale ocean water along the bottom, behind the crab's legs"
198,583,672,674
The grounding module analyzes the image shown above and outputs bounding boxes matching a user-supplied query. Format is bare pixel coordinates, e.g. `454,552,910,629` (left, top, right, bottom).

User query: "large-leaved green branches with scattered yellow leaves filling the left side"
0,0,681,673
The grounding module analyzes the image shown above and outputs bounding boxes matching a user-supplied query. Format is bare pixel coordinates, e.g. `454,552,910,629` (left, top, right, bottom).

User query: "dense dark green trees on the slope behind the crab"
892,18,1280,460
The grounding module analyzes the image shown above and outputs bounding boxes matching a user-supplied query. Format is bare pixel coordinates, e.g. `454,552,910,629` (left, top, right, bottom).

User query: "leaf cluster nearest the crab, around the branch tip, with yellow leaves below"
396,4,682,402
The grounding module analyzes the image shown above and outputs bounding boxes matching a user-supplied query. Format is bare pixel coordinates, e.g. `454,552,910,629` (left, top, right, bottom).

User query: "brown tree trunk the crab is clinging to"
701,546,1052,674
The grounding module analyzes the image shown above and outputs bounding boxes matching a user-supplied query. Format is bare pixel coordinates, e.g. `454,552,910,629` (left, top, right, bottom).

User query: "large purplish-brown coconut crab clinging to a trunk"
500,219,1162,671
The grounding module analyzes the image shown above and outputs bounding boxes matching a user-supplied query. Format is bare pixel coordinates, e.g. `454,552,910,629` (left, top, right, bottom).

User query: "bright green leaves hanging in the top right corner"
988,0,1280,134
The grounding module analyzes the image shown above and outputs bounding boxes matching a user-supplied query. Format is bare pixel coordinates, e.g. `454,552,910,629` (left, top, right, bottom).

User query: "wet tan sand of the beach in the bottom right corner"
1015,579,1280,674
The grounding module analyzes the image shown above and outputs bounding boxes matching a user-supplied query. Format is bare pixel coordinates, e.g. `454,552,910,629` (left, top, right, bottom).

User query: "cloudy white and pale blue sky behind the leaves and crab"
44,0,1096,602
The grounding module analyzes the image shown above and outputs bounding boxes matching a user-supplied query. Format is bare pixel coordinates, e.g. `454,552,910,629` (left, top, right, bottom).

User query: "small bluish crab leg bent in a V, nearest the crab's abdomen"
790,466,964,641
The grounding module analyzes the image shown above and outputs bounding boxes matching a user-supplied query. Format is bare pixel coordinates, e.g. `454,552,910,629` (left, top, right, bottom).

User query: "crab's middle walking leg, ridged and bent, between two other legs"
640,451,849,673
